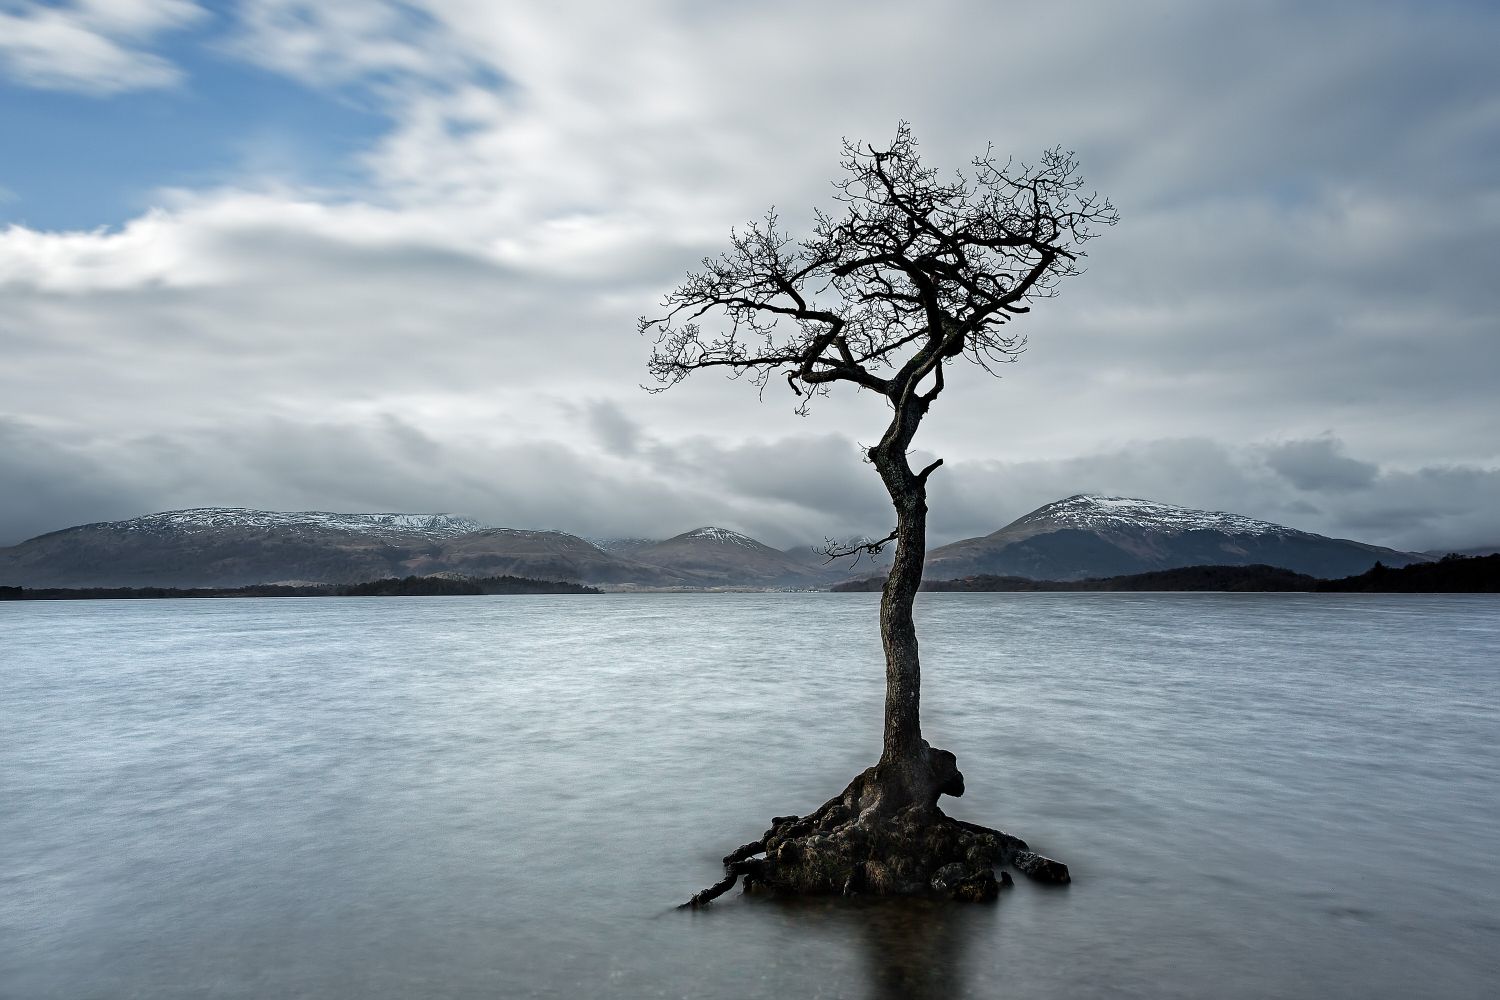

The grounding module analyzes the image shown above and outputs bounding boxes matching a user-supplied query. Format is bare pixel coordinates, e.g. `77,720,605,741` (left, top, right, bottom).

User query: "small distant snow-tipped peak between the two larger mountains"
630,528,848,586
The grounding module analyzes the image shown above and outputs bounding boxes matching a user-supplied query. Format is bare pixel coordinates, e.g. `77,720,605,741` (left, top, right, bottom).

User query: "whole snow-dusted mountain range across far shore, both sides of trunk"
0,493,1431,589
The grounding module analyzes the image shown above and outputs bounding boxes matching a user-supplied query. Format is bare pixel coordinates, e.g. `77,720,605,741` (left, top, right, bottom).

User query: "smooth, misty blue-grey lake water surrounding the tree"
0,594,1500,1000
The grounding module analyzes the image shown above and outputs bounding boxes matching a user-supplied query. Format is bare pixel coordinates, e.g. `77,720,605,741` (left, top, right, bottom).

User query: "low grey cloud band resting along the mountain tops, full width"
0,413,1500,550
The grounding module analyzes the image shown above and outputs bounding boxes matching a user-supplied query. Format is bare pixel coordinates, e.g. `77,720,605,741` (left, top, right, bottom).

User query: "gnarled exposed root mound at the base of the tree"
680,744,1070,909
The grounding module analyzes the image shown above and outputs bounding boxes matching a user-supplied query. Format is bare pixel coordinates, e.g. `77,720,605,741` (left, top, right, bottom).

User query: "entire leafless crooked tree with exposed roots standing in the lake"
639,123,1118,906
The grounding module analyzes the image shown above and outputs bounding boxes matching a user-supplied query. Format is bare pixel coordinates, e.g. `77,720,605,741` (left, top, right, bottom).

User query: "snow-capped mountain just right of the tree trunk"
926,493,1428,580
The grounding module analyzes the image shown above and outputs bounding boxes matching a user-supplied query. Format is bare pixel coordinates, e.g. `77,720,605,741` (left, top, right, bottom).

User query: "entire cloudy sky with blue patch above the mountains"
0,0,1500,549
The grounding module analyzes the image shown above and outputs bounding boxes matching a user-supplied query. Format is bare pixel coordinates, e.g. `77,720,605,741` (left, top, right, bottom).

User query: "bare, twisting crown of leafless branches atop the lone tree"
639,123,1118,412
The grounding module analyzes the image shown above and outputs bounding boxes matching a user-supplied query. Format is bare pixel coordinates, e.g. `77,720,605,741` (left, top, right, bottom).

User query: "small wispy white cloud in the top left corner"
0,0,204,94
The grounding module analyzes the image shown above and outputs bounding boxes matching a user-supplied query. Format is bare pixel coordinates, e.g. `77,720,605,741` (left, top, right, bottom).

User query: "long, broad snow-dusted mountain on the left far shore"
0,507,687,588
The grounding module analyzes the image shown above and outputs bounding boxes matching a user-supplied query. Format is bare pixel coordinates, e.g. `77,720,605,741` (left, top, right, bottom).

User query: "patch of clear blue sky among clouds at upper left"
0,16,390,231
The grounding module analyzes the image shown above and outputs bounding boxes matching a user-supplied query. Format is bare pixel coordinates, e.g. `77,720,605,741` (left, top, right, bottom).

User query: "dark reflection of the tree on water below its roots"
756,897,1005,1000
